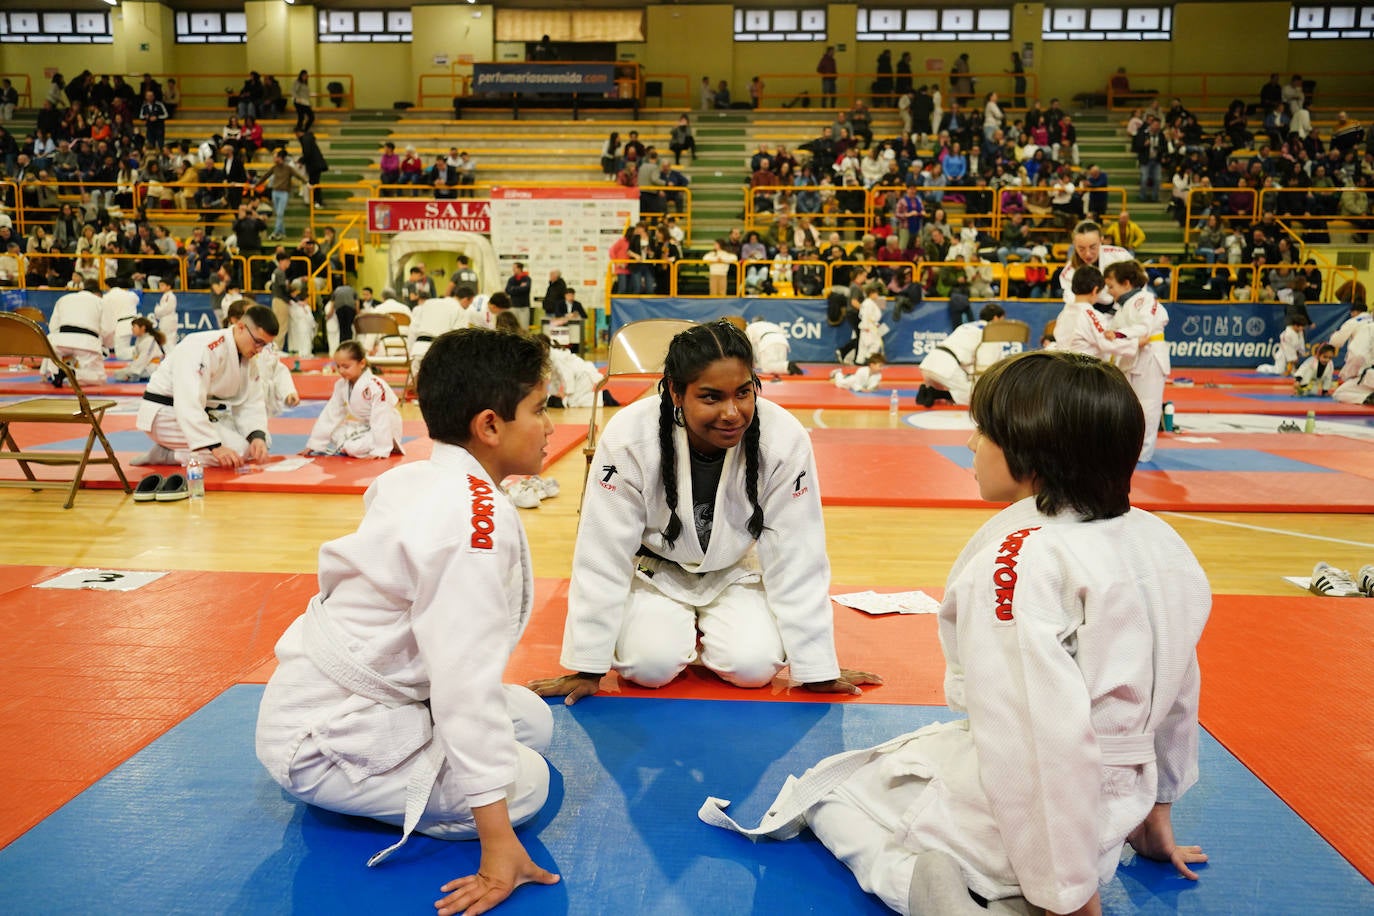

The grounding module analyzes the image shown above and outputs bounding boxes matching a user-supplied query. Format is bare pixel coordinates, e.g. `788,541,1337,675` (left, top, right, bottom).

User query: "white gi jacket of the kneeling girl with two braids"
561,397,840,683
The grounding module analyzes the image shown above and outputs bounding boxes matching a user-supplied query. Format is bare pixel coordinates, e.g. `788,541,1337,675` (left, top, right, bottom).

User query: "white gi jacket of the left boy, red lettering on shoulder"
257,442,534,809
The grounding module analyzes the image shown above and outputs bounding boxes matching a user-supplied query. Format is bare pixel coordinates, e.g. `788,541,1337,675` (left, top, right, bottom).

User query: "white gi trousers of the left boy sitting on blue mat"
284,684,554,839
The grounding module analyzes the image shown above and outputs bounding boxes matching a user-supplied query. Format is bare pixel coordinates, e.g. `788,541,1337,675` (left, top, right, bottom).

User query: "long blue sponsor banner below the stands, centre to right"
610,297,1349,368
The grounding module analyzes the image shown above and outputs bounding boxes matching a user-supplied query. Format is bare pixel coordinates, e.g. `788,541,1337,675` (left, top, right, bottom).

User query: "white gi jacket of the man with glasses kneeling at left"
137,328,267,450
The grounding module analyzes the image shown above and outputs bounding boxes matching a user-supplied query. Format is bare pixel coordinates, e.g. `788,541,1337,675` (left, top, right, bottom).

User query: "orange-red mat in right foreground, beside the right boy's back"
1198,596,1374,880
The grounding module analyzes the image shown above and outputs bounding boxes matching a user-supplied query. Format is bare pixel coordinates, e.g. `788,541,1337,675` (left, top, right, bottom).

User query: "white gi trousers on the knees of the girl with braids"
614,577,786,688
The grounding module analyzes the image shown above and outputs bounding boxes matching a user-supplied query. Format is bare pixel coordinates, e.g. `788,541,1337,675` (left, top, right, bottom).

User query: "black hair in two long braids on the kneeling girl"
658,320,764,545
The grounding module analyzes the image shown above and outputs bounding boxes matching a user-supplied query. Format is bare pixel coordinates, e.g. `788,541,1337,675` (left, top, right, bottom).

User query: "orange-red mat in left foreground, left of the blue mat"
0,567,317,846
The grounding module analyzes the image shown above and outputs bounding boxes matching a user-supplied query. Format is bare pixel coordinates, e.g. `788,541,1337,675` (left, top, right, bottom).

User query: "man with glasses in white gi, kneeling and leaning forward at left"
131,305,278,467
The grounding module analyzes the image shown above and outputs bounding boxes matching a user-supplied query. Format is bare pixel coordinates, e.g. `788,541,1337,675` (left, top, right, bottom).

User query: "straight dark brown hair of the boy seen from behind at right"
969,351,1145,522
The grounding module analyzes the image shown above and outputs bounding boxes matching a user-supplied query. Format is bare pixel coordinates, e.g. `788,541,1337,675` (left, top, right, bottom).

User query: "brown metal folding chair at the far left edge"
0,313,133,509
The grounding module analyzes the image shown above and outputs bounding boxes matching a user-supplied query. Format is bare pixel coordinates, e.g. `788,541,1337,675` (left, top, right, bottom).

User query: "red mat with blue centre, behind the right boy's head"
811,428,1374,512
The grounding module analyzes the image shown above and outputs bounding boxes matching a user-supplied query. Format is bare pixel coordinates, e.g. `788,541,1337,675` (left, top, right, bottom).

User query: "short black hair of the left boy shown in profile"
415,328,548,445
